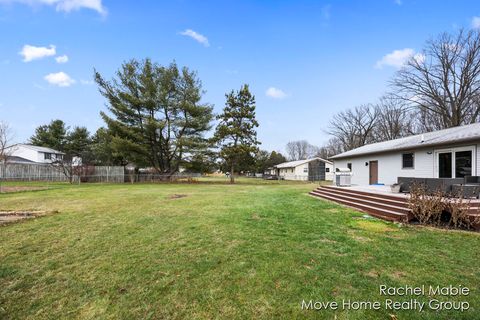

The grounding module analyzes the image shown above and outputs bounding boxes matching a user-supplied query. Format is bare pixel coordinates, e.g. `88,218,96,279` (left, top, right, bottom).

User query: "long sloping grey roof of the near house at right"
330,123,480,159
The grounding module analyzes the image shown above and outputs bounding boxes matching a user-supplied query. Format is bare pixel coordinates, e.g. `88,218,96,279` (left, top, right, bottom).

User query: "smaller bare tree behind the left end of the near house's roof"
327,104,378,151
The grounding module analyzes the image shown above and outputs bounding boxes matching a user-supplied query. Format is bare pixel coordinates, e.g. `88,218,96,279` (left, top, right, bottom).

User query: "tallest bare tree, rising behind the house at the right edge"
392,30,480,131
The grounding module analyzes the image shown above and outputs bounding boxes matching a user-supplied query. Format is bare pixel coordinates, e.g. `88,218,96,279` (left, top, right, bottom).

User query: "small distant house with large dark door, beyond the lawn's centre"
275,158,333,181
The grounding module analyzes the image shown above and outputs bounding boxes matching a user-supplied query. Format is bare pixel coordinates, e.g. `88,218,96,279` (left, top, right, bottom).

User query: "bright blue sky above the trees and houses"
0,0,480,151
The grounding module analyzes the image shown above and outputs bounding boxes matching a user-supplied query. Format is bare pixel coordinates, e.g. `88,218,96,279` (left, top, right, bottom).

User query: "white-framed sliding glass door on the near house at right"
435,146,475,178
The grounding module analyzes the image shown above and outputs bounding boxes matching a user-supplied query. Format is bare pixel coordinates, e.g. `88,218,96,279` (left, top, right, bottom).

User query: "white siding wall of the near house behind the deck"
334,144,480,185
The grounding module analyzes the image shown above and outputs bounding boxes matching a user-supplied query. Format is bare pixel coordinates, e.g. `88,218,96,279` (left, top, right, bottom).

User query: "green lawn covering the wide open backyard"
0,180,480,319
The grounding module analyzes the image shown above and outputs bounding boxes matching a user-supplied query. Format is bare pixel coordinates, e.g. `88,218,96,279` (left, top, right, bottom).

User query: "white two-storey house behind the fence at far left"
6,144,65,164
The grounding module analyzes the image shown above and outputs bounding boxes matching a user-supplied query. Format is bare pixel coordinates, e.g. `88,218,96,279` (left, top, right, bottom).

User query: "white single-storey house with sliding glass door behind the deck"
330,123,480,185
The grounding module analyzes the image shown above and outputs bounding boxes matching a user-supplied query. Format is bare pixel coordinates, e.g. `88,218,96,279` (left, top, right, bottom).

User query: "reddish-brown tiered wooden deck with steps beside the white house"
309,186,480,228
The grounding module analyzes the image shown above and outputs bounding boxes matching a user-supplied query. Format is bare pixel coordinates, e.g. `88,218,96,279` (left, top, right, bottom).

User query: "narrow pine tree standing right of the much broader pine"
214,84,260,183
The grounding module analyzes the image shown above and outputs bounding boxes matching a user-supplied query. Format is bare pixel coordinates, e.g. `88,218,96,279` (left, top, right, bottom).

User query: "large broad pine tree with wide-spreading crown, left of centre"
95,59,213,177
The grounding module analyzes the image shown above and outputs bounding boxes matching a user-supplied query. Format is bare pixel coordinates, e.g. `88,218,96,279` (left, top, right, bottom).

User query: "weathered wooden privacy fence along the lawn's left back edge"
0,163,125,183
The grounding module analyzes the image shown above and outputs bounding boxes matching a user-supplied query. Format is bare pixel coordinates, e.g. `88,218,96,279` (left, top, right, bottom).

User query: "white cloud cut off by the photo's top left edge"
0,0,107,15
